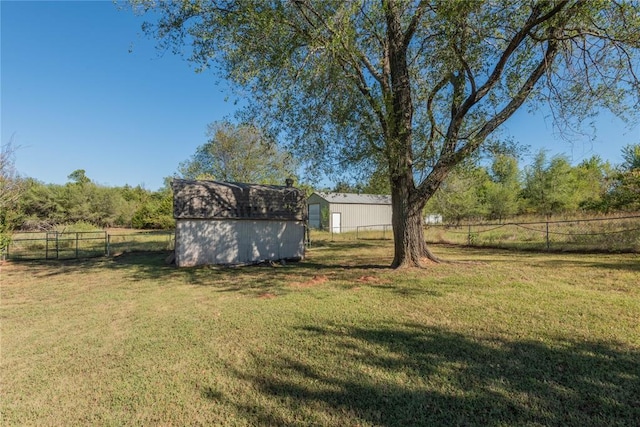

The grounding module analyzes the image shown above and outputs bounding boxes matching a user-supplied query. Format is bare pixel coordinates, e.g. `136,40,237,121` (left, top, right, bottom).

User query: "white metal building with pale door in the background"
307,192,391,233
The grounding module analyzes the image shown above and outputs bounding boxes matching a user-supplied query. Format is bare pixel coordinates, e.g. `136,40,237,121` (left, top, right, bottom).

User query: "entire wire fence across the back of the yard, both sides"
6,215,640,260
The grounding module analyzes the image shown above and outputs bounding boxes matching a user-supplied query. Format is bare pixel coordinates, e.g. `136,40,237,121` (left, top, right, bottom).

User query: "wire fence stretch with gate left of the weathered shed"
3,230,175,260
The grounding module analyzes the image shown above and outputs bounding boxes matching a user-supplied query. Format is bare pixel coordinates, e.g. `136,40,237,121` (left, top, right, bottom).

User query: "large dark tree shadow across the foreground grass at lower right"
216,324,640,426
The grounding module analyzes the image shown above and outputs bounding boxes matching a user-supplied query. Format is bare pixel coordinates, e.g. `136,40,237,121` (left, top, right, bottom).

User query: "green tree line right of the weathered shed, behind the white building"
332,144,640,222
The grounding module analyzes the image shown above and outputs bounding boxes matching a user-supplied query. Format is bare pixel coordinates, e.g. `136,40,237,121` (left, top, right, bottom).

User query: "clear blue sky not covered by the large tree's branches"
0,1,640,190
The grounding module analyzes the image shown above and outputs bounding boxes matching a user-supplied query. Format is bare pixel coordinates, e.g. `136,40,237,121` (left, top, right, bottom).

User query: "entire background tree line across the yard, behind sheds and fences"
0,117,640,237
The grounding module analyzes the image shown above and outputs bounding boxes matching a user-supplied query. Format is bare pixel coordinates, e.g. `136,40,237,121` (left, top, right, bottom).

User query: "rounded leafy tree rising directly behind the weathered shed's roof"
178,121,296,185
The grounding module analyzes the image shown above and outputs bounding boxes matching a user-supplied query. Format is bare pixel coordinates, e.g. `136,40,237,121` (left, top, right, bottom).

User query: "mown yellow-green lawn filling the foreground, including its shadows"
0,241,640,426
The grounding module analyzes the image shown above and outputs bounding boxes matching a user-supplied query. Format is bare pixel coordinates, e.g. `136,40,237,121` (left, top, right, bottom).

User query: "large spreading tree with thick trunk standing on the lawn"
132,0,640,267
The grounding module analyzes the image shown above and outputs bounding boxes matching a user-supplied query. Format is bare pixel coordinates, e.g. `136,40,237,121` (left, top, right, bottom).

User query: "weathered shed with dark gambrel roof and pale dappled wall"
172,179,306,267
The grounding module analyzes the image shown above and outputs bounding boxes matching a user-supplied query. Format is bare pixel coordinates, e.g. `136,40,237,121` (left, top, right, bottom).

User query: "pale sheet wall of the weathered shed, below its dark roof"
175,219,304,267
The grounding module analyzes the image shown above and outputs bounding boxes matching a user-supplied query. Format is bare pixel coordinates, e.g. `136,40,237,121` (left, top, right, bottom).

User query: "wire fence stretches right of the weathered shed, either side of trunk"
310,215,640,252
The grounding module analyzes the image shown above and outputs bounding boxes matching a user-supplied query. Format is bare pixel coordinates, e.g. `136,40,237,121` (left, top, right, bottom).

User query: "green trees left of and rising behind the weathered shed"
0,121,302,237
